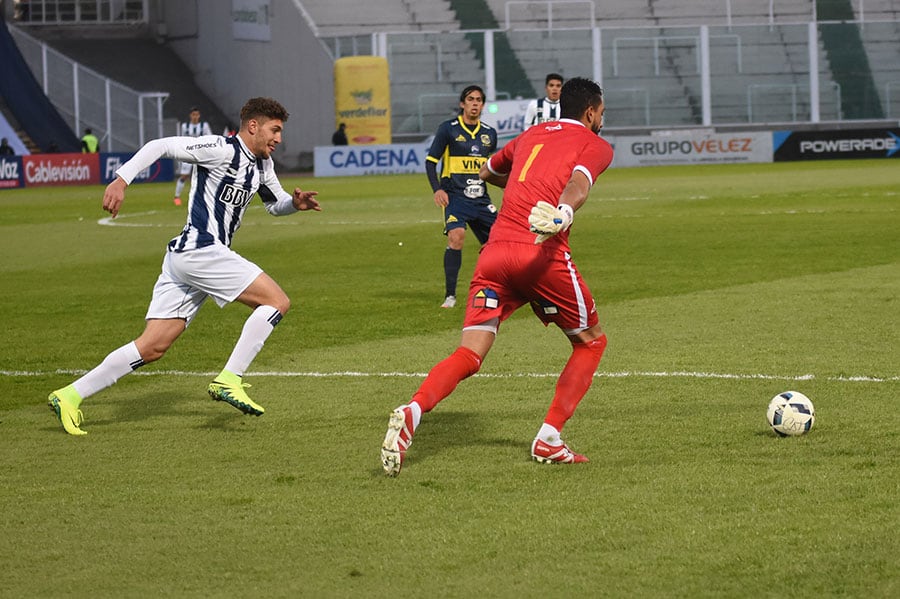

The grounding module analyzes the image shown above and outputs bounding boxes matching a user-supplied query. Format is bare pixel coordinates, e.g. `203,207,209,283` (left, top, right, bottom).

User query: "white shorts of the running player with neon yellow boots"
146,245,263,324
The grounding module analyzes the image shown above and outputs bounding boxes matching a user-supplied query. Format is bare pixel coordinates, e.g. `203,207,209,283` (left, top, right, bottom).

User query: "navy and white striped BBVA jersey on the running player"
116,135,297,252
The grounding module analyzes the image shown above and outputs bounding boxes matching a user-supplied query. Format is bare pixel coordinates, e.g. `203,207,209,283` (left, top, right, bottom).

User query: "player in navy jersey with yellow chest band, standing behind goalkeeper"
425,85,497,308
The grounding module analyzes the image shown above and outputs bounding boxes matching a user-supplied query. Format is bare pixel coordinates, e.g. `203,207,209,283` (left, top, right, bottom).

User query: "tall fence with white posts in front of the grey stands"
322,18,900,135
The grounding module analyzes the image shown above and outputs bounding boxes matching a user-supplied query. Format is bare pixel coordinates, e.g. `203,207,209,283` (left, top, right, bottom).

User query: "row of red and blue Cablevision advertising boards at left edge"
0,152,175,189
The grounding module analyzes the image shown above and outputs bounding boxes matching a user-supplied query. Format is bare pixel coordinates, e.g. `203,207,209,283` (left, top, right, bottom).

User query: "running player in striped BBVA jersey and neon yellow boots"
48,98,320,435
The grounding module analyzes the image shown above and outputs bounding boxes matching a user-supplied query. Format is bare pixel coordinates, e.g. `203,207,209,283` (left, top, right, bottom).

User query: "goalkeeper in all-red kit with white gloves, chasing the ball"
381,78,613,476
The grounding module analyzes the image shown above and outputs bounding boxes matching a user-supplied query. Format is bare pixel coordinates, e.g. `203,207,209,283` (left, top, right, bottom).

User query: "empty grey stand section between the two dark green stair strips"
488,0,841,126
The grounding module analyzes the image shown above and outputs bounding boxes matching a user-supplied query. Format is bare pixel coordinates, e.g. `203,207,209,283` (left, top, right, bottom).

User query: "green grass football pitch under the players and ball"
0,160,900,598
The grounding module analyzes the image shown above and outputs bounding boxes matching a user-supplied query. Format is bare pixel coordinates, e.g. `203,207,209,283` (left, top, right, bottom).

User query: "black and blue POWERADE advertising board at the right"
772,129,900,162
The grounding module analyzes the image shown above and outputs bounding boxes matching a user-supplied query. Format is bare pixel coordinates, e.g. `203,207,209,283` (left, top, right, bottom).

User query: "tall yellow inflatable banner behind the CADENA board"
334,56,391,145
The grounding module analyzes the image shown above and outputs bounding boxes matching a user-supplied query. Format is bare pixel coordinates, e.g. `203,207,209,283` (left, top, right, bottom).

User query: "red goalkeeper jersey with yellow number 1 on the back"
488,119,613,250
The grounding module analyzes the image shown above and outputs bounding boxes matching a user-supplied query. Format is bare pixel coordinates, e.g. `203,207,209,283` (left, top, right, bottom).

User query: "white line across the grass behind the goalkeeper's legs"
0,368,900,383
